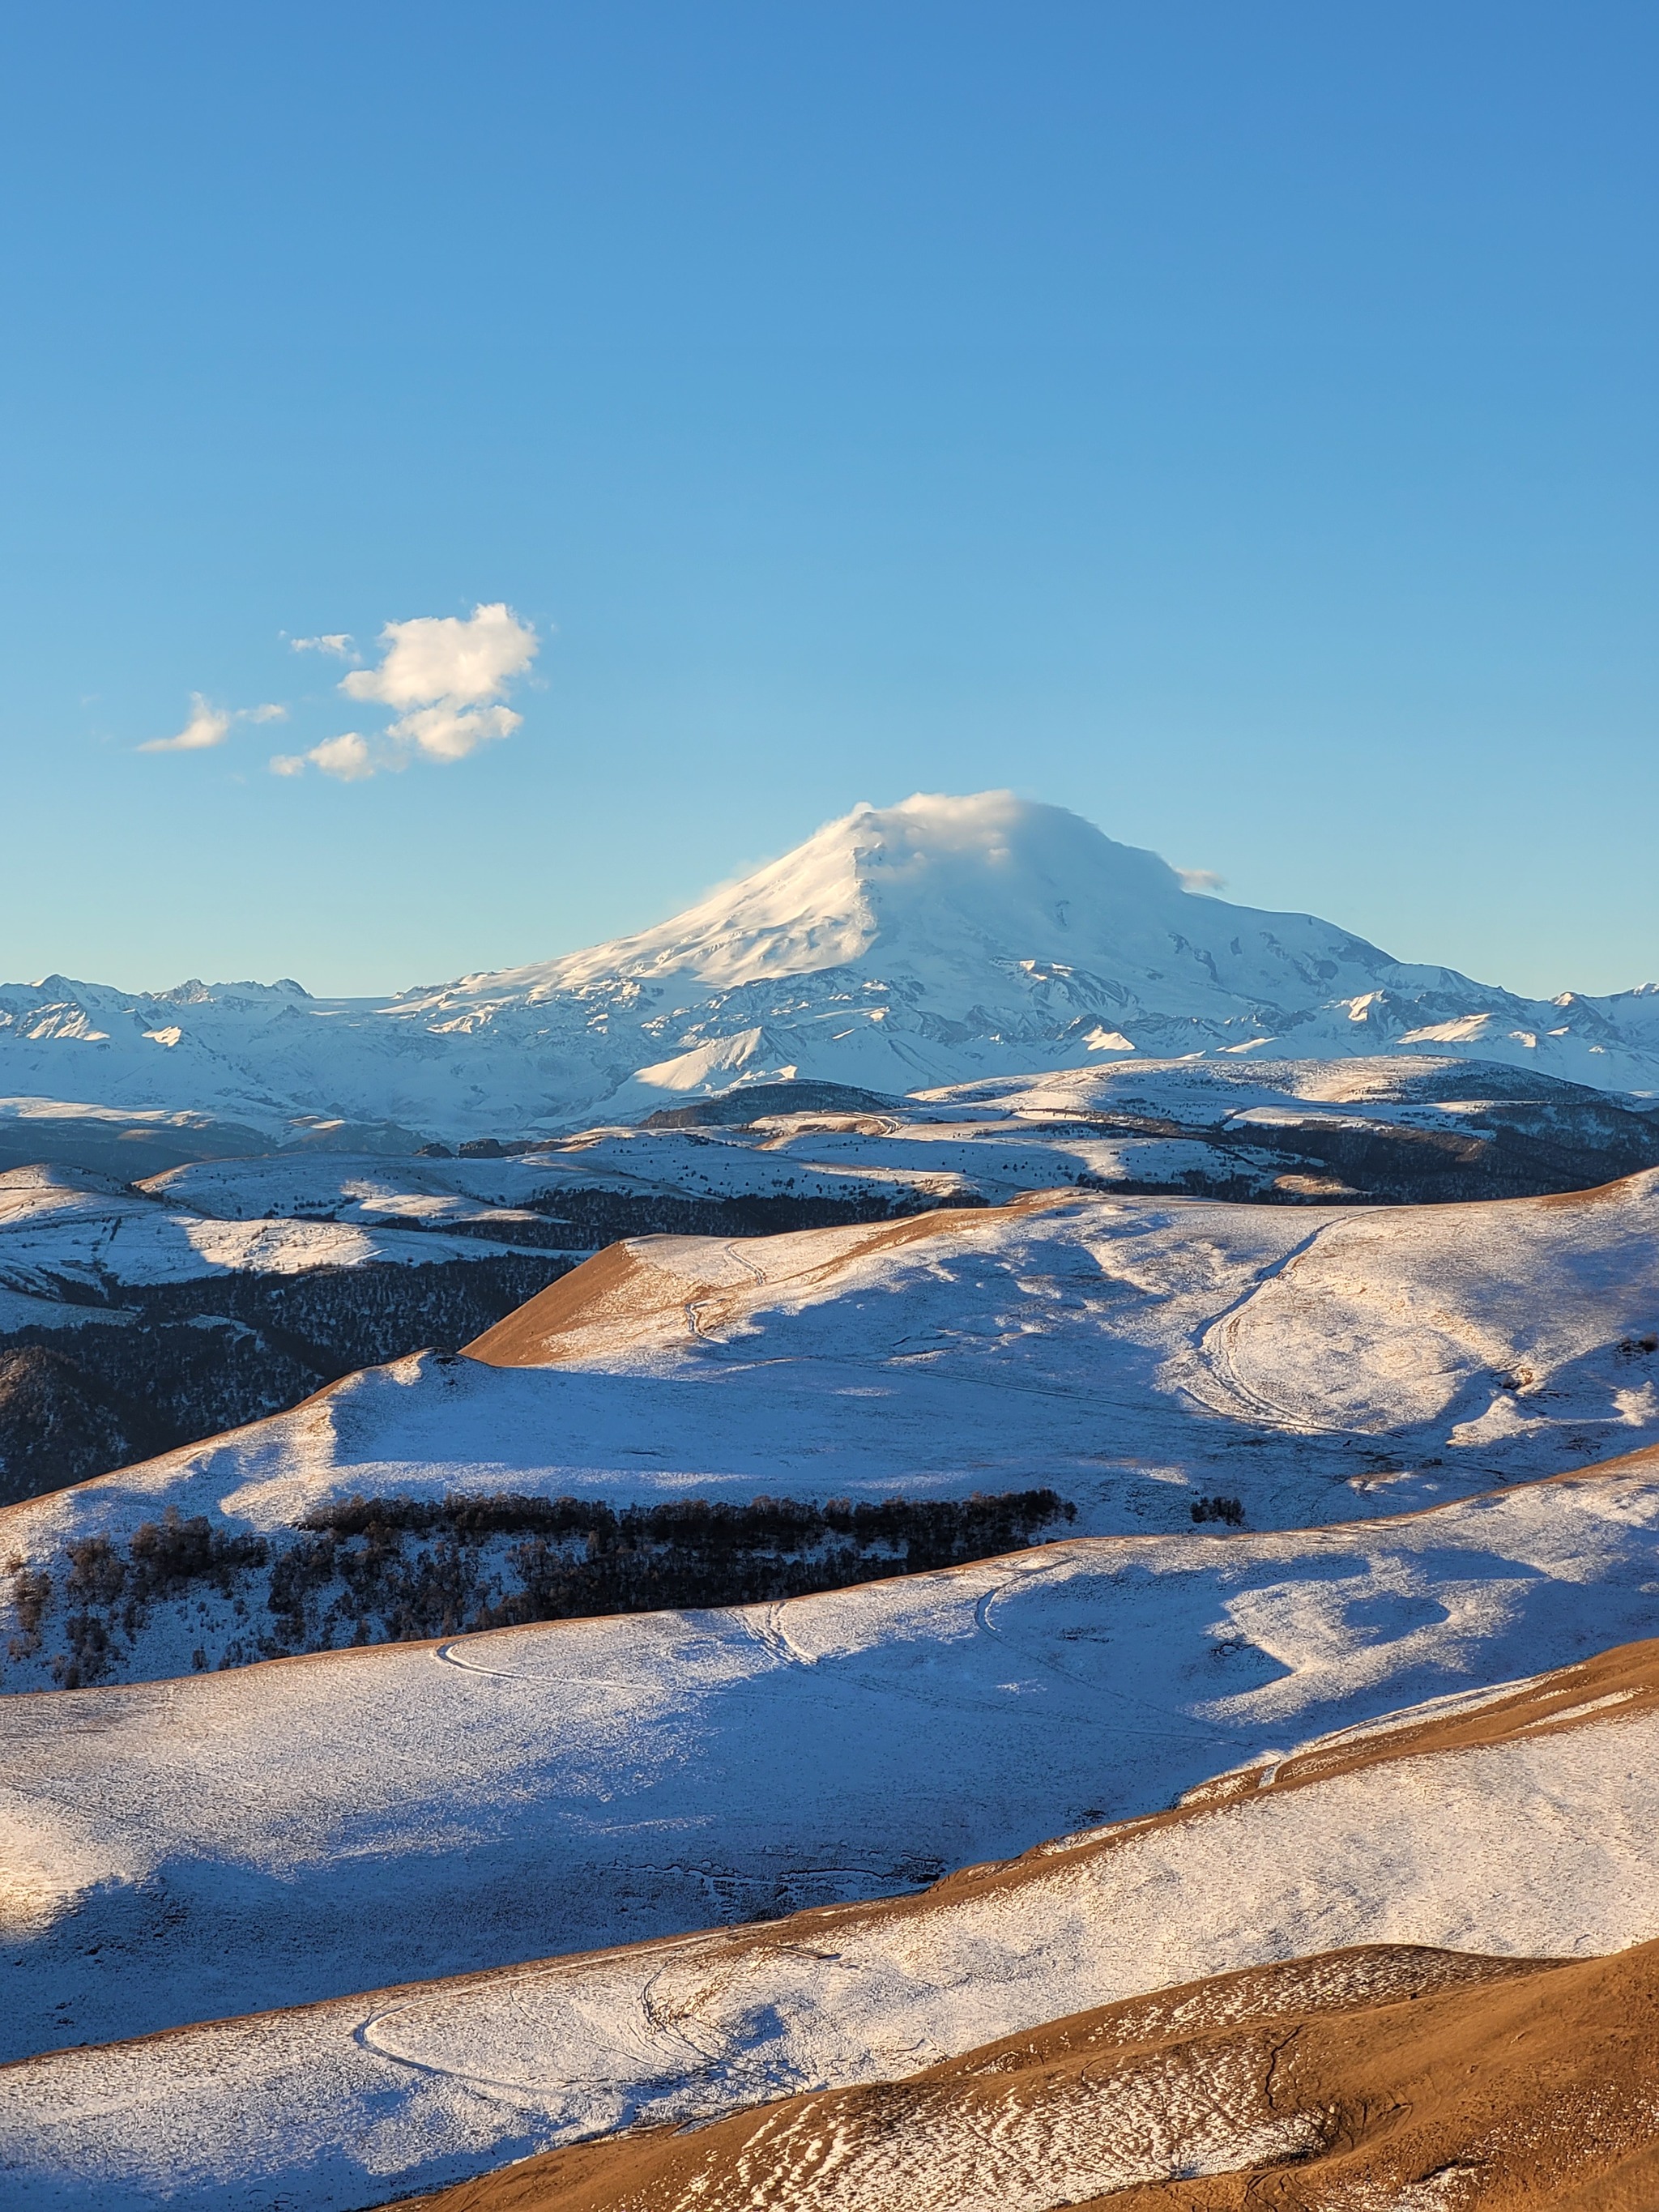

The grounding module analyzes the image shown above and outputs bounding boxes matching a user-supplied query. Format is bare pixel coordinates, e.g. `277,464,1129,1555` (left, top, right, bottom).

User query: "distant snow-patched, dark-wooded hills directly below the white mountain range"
0,1055,1659,1502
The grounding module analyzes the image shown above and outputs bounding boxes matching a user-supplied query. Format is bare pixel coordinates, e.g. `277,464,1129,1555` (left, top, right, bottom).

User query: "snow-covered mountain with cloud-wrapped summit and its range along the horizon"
0,792,1659,1137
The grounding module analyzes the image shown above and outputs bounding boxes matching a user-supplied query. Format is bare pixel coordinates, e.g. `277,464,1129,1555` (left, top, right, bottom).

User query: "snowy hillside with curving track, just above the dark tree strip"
0,1170,1659,1690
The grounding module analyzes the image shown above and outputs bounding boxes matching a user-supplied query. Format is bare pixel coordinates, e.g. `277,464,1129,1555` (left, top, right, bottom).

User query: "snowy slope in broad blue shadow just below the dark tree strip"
0,1455,1659,2060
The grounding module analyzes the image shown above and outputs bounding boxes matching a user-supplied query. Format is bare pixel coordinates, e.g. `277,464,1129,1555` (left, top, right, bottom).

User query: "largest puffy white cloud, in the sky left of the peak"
270,602,539,783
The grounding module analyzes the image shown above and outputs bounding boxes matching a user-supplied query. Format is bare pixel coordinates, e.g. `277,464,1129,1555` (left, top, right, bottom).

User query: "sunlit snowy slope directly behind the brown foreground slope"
0,1663,1659,2212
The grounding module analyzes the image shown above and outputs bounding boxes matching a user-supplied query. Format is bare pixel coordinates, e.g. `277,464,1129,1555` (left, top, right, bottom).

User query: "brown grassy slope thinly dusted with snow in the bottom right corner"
386,1945,1659,2212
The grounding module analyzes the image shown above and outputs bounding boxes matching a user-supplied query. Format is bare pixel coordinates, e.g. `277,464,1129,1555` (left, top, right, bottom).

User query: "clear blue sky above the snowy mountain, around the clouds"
0,0,1659,991
